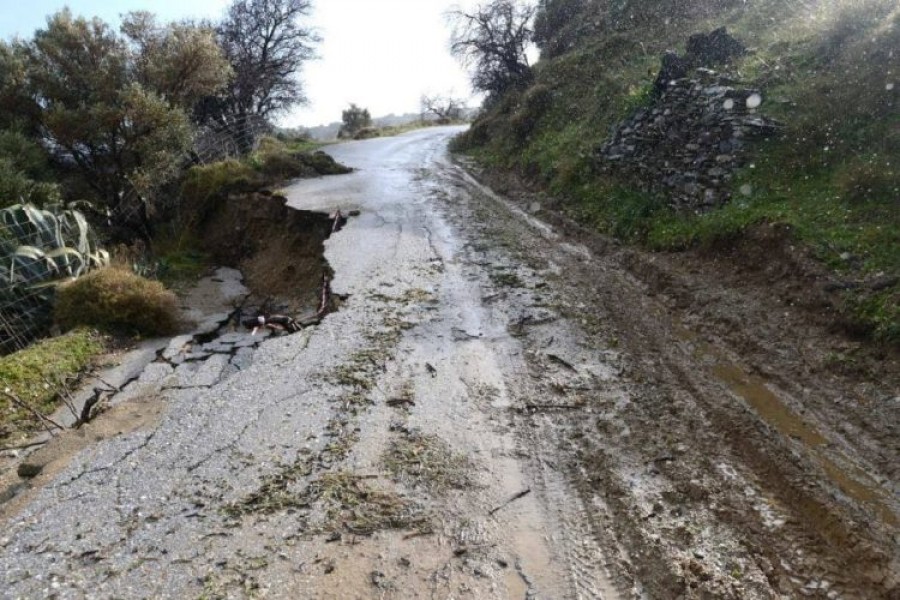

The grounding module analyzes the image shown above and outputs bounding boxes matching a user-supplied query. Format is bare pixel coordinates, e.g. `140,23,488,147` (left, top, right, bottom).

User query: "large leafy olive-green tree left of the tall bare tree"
18,10,228,237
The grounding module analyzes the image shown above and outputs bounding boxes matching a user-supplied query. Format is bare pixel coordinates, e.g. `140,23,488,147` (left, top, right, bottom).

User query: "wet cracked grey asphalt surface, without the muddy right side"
0,128,620,598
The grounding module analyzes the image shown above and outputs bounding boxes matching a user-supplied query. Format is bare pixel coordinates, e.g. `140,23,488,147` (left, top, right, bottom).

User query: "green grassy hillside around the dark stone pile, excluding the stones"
456,0,900,343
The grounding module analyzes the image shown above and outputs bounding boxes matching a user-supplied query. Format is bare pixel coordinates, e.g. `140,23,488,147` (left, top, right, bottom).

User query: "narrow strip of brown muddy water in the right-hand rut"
674,322,900,528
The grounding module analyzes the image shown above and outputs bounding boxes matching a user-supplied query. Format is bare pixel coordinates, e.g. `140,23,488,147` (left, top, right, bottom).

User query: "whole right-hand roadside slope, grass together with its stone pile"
455,0,900,346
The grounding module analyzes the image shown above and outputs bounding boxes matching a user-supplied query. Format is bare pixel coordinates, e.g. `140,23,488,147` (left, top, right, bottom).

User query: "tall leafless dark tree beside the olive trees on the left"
202,0,319,151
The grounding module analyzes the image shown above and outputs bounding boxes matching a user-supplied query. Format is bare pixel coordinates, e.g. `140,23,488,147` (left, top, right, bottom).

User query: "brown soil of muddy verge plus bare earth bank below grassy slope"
460,162,900,598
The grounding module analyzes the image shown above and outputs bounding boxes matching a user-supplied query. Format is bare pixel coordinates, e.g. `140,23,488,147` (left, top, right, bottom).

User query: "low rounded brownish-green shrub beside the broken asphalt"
54,267,178,336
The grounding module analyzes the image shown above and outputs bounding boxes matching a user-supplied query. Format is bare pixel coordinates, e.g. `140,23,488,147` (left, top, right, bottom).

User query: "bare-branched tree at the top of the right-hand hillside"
450,0,536,99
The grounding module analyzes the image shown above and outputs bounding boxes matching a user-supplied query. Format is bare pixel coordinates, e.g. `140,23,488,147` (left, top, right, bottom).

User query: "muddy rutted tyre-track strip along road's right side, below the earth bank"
442,157,898,598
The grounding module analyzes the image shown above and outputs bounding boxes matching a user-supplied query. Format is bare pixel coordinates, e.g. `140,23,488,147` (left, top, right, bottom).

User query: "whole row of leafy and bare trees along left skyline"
0,0,319,238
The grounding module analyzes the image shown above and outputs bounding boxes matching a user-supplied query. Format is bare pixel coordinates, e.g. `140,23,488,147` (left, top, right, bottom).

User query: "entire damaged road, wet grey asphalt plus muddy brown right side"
0,128,900,599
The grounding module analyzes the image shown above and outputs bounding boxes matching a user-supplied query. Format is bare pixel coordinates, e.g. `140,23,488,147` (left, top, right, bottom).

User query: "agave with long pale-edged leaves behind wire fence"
0,204,109,351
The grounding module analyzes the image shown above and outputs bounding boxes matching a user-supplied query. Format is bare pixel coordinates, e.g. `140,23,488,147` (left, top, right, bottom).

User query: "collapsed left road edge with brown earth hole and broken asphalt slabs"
0,193,346,518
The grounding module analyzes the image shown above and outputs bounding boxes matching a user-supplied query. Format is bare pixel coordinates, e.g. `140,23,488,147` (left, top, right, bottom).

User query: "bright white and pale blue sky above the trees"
0,0,474,127
